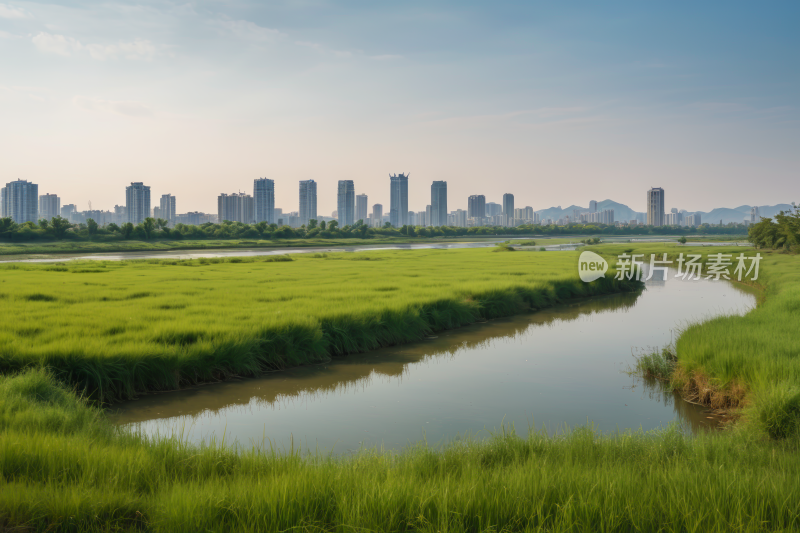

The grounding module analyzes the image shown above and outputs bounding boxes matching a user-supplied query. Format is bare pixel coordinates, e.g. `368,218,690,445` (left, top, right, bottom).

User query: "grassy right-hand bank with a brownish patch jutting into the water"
592,245,800,438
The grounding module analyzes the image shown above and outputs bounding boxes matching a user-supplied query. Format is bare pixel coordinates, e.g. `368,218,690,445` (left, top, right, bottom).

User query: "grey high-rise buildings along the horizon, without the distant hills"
0,179,728,228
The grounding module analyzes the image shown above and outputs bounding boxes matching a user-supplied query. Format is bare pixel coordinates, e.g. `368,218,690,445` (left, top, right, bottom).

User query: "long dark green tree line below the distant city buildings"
0,217,747,242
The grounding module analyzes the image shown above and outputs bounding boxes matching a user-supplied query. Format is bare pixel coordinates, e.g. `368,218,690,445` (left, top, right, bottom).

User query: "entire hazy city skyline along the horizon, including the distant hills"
2,174,791,227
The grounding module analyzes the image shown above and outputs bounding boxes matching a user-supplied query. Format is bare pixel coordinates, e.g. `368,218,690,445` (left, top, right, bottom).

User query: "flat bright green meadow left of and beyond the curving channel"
0,249,637,400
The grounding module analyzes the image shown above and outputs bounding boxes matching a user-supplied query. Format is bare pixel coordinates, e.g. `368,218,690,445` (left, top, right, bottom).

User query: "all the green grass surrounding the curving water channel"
0,243,800,532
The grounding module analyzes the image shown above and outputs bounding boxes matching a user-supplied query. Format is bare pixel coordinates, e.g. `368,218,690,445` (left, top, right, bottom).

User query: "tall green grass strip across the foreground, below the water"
0,370,800,532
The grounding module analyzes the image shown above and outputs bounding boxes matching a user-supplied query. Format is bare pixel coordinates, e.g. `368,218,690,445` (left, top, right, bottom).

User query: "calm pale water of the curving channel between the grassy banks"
111,275,755,453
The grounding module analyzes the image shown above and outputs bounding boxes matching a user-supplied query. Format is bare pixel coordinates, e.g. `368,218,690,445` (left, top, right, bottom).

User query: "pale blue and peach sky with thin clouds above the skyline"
0,0,800,215
